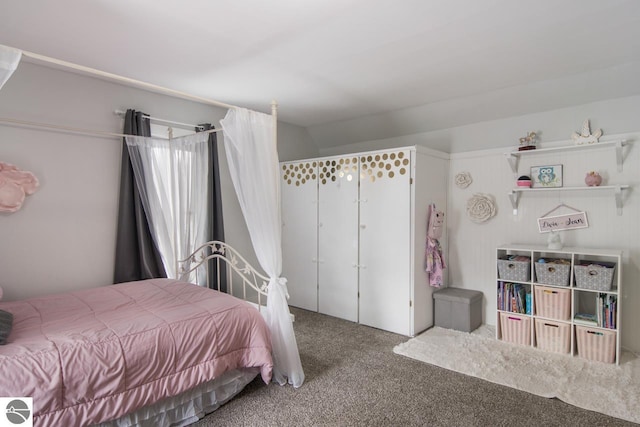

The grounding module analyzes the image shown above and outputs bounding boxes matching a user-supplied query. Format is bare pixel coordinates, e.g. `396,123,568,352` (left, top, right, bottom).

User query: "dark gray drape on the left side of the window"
113,110,167,283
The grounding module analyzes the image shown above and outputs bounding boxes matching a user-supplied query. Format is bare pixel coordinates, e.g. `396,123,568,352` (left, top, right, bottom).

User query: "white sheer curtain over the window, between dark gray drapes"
125,133,209,285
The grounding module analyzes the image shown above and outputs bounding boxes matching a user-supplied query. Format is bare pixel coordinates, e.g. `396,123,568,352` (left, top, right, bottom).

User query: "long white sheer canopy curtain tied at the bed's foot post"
220,108,304,388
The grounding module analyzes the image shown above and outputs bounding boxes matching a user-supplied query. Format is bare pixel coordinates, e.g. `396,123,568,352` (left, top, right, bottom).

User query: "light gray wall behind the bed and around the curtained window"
0,62,318,299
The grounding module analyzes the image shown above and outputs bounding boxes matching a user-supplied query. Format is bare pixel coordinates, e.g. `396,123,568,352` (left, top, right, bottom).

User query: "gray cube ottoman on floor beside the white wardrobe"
433,288,482,332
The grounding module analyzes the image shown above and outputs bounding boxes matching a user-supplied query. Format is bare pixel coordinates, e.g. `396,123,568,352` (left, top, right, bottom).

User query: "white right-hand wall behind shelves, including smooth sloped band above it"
322,97,640,351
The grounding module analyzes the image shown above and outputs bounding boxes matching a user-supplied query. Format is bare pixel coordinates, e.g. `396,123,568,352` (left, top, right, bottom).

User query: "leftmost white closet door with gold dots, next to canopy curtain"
280,161,318,311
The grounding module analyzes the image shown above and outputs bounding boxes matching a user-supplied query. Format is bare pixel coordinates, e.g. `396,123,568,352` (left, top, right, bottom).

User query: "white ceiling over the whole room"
0,0,640,149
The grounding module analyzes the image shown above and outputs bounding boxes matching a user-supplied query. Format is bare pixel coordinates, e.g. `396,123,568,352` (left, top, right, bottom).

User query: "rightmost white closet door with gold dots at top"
359,150,411,335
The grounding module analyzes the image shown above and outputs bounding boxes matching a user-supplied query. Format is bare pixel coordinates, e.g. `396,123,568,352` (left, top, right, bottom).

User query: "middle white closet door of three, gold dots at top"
318,157,358,322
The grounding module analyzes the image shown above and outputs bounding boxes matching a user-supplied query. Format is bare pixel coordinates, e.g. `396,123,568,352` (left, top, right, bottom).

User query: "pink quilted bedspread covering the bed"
0,279,273,426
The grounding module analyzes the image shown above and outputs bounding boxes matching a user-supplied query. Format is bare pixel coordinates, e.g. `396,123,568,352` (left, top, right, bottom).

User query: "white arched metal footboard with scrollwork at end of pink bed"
178,240,269,310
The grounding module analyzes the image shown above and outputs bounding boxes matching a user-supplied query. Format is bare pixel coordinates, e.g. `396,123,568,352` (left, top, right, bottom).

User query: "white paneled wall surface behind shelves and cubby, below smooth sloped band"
446,138,640,351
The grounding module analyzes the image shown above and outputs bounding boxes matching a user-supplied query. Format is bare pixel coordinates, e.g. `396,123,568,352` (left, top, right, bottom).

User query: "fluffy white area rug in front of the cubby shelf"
393,325,640,423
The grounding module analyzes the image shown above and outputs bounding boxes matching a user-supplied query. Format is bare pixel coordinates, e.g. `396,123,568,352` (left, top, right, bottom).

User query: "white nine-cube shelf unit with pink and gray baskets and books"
496,244,622,364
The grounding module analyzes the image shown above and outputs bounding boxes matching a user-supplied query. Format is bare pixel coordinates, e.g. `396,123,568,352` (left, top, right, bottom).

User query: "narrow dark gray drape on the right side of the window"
201,123,227,292
